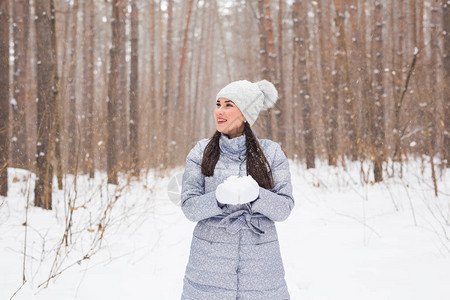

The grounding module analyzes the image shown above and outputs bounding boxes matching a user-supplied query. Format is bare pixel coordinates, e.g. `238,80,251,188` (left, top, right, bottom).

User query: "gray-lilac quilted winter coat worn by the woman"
181,134,294,300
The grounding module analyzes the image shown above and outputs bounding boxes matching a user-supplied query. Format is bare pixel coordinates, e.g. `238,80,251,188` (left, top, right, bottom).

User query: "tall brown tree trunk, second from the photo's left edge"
11,0,30,169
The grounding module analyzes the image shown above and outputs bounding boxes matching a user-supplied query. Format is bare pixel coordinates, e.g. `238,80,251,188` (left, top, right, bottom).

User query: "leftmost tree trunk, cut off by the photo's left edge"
0,1,9,197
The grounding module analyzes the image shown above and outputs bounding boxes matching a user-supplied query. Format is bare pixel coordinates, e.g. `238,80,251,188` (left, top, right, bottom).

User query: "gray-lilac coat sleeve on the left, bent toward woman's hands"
181,142,227,222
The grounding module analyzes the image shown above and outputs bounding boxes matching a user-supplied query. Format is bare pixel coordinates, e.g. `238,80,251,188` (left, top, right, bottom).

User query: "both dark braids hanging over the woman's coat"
202,122,274,189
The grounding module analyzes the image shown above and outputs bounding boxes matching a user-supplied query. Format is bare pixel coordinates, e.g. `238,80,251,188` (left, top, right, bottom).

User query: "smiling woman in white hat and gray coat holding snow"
181,80,294,300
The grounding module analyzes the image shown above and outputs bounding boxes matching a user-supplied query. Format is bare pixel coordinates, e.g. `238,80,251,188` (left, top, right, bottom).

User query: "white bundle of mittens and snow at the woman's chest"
216,175,259,205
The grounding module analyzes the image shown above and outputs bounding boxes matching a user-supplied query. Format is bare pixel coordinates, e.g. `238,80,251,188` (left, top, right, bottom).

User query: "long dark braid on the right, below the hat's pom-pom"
244,122,274,189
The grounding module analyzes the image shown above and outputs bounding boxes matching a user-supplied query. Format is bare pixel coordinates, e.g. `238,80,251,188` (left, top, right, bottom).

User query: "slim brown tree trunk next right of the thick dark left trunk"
67,0,80,175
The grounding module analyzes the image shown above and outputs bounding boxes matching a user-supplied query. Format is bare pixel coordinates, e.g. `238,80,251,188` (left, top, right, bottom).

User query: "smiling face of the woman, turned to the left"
214,98,245,139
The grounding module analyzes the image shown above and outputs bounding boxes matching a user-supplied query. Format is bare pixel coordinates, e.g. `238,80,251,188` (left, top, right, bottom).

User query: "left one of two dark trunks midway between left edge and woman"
106,0,122,184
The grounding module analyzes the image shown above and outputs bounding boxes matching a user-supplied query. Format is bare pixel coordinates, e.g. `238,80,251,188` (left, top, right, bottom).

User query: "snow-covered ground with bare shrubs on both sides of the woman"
0,162,450,300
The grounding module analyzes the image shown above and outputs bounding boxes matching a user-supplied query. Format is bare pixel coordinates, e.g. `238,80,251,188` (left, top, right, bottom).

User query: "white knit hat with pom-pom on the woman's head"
216,80,278,126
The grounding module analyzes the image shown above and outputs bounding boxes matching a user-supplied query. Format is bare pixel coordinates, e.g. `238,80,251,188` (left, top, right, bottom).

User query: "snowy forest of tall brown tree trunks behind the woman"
0,0,450,208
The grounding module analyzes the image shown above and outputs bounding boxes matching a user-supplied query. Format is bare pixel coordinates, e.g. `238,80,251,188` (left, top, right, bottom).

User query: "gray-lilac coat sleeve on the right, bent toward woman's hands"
251,144,294,221
